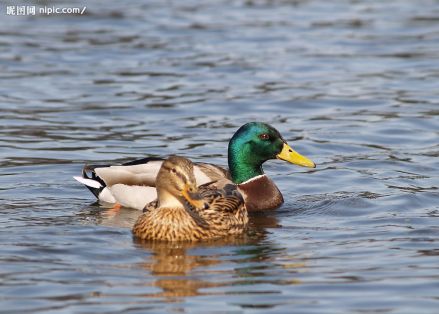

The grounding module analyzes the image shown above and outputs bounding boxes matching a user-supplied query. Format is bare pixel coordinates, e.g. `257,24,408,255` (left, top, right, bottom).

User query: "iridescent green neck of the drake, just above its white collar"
228,146,264,184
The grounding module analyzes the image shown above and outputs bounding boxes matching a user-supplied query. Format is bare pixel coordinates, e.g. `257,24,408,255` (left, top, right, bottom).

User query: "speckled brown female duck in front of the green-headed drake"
133,156,248,241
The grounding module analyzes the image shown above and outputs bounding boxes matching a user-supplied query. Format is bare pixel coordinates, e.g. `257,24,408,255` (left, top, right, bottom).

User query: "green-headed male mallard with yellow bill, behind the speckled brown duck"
75,122,315,211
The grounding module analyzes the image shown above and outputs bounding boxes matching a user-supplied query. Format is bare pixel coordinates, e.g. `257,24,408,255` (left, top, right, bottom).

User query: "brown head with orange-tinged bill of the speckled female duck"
156,156,207,209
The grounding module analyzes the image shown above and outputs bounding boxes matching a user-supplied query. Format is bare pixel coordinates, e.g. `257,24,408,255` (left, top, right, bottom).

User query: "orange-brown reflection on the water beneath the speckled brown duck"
134,211,292,302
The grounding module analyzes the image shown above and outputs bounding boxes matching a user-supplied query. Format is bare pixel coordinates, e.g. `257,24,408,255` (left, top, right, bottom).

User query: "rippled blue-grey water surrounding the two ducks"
0,0,439,313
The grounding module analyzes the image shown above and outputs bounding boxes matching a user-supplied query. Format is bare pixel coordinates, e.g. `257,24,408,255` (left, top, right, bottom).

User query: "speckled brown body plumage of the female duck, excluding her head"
133,156,248,241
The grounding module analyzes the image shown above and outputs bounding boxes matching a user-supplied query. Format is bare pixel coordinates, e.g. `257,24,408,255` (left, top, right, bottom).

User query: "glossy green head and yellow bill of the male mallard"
228,122,316,184
